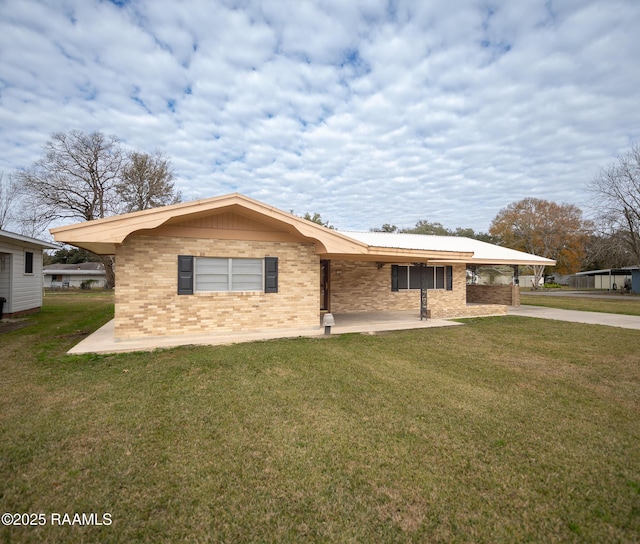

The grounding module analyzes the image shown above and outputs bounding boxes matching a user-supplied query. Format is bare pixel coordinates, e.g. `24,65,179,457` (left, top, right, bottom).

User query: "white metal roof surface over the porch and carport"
341,231,555,266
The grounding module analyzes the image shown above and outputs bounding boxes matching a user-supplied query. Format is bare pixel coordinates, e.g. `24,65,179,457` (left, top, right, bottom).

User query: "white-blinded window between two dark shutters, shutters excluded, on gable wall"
195,257,264,292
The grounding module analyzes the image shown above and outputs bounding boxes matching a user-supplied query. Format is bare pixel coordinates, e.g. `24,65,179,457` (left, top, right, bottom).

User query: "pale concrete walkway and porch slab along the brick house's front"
67,312,461,355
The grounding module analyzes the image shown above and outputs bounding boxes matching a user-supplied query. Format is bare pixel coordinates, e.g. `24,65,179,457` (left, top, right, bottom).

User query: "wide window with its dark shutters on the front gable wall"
178,255,278,295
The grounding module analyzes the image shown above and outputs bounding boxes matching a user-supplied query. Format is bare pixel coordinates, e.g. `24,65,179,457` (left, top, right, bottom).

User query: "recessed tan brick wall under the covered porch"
330,260,506,319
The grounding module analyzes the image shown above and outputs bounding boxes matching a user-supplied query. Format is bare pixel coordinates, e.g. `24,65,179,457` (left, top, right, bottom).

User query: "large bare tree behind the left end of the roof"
17,130,124,286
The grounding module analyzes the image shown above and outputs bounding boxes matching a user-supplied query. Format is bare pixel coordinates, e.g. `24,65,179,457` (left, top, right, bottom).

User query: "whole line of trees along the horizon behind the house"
0,130,640,285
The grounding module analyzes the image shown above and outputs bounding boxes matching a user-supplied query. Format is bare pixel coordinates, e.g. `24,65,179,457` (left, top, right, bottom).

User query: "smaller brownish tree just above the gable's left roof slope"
116,151,182,212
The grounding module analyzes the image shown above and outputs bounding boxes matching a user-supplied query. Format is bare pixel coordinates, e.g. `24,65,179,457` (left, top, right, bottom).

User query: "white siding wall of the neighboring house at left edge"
0,239,42,313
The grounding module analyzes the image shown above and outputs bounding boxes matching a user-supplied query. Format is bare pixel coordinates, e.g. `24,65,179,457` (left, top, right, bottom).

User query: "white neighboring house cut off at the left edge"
0,230,60,317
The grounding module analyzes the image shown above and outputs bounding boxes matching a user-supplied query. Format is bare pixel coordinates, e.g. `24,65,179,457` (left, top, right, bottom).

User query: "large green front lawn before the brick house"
0,296,640,543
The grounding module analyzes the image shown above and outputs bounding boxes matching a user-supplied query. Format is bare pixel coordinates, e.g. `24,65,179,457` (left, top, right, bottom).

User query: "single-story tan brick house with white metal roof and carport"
51,193,555,339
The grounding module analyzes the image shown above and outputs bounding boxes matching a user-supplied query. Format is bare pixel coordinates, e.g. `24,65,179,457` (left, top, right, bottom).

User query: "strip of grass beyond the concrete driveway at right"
520,293,640,315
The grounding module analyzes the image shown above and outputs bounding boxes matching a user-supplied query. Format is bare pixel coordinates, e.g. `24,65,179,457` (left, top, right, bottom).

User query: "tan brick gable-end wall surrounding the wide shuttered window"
115,235,320,338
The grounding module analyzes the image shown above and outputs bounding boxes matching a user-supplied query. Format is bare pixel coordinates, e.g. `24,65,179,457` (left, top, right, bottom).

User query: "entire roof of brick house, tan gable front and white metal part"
51,193,555,265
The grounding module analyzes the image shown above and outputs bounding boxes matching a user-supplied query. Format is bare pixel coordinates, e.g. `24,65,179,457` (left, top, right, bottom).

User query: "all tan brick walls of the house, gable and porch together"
115,235,511,339
